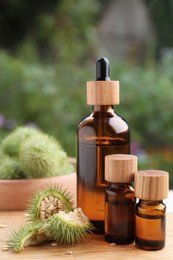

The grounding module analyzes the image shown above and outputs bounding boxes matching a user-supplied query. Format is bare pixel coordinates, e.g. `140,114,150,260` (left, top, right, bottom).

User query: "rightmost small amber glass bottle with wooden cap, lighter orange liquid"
135,170,169,250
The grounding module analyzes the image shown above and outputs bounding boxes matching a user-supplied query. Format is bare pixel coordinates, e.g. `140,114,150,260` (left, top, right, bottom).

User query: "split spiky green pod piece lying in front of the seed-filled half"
45,208,92,245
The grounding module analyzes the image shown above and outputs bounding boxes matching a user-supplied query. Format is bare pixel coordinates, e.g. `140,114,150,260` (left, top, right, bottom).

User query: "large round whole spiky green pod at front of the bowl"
19,135,72,178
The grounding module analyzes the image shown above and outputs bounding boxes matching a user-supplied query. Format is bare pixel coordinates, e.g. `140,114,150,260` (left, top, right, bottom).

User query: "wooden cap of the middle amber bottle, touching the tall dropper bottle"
105,154,137,183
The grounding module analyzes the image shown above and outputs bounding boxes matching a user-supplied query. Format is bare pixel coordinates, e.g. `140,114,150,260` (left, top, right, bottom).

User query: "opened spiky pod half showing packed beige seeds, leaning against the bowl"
28,187,74,221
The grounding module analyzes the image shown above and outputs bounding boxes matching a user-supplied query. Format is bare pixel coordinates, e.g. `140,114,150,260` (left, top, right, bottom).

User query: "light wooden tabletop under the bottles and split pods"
0,211,173,260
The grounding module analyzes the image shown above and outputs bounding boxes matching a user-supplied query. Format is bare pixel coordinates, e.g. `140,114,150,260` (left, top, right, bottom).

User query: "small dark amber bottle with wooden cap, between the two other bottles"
105,154,137,244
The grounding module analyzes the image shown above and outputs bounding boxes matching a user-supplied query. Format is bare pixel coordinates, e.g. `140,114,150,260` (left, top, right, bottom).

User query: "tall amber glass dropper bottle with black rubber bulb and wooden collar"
77,57,130,233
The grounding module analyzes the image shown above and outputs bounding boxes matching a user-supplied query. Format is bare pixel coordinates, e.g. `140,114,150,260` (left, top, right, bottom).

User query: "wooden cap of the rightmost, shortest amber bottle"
135,170,169,200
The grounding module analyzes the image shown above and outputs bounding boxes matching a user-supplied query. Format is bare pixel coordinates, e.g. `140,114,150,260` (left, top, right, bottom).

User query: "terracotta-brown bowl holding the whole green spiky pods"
0,159,76,211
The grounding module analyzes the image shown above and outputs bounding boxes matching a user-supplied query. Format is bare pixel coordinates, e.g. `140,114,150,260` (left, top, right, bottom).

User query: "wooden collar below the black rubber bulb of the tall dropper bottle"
87,81,120,105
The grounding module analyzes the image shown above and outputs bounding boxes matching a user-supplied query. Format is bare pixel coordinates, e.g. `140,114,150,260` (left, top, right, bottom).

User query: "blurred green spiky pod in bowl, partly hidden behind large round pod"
1,127,41,157
